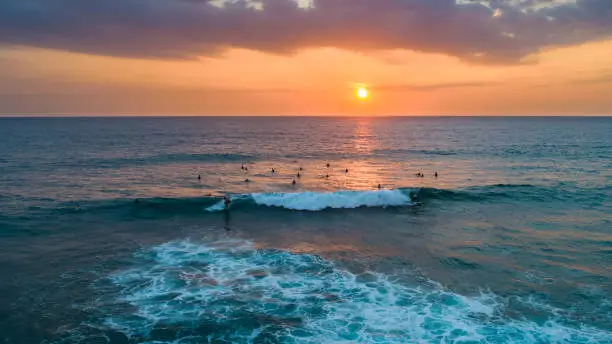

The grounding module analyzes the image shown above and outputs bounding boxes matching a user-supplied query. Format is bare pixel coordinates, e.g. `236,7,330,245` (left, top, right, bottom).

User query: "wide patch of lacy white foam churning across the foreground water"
106,241,609,344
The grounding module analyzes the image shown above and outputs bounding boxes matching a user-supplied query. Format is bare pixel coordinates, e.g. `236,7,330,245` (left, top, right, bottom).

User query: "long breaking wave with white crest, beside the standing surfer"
29,184,592,217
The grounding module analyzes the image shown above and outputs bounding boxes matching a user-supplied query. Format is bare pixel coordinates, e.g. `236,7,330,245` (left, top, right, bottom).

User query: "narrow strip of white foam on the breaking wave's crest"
252,190,412,211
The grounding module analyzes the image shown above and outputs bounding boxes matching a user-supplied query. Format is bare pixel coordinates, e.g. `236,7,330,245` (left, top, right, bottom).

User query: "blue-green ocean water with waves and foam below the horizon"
0,117,612,344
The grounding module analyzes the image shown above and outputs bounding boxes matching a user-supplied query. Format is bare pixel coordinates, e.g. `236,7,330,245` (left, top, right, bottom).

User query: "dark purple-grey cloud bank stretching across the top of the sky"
0,0,612,63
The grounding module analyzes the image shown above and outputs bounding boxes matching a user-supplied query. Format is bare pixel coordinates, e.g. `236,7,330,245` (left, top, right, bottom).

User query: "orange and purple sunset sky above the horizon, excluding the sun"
0,0,612,116
